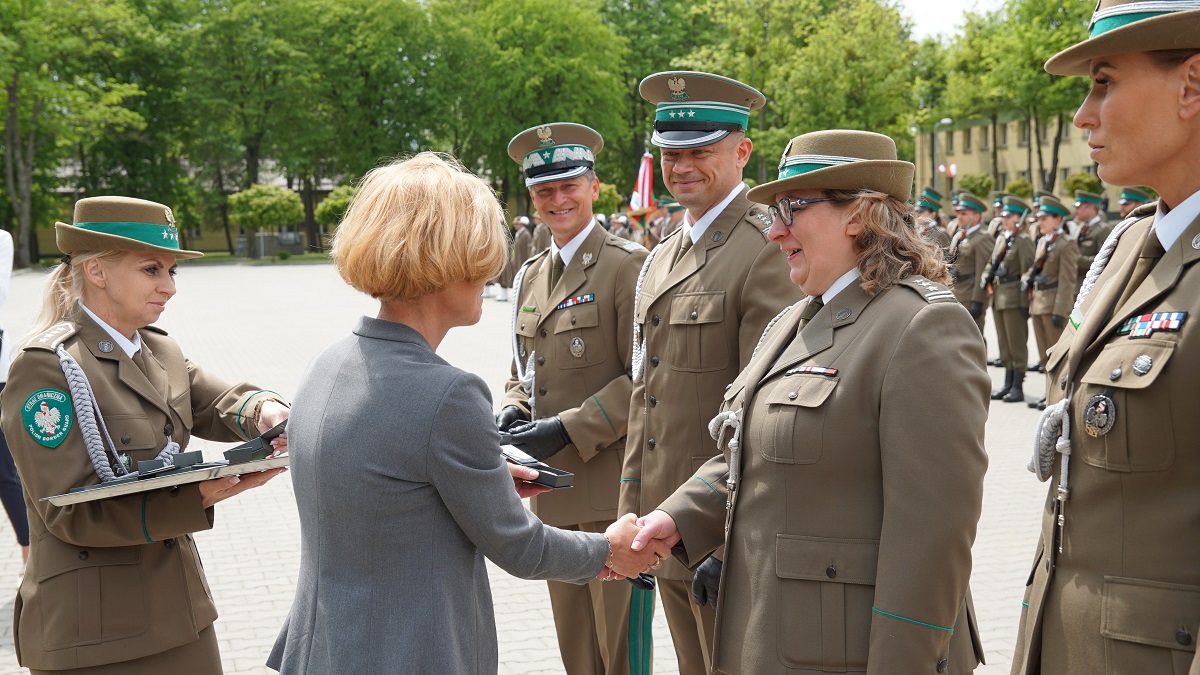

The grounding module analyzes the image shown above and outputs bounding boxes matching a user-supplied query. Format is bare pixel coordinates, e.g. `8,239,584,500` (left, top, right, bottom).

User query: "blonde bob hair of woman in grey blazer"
330,153,509,303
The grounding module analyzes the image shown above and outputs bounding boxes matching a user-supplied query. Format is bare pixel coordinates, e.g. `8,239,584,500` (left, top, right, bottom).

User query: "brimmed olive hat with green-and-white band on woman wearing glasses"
746,129,917,204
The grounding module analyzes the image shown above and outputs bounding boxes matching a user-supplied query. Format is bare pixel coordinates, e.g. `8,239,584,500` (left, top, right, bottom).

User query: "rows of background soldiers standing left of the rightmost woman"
916,186,1151,410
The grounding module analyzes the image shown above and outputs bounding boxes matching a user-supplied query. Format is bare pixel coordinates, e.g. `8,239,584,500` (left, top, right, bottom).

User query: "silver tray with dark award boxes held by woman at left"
41,422,288,507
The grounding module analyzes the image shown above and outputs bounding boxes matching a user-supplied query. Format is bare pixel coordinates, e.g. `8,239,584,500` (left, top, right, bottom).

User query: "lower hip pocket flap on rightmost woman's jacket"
1100,577,1200,651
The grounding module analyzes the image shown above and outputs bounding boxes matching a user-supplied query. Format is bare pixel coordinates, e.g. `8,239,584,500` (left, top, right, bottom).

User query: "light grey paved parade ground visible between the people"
0,263,1046,675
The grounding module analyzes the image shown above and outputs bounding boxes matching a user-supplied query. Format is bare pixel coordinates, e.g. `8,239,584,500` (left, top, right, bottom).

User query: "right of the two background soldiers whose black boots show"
1021,197,1079,410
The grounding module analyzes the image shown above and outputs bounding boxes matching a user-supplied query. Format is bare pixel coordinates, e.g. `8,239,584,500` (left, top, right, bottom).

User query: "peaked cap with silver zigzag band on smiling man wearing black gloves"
509,121,604,187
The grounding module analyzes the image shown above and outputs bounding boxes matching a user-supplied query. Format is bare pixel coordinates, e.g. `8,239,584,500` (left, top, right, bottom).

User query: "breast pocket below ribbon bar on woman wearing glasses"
749,374,838,464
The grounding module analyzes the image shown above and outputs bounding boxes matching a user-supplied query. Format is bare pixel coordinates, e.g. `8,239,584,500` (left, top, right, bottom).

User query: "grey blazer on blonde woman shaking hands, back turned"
266,317,608,675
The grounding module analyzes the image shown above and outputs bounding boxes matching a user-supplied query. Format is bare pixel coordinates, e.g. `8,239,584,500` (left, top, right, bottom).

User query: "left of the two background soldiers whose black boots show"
980,197,1033,404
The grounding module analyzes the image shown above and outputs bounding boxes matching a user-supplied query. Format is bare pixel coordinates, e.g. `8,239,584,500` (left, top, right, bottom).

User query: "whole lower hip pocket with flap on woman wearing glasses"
775,534,880,673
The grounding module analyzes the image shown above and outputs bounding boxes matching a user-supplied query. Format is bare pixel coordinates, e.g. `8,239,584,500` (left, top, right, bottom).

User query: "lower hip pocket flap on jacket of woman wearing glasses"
775,534,880,586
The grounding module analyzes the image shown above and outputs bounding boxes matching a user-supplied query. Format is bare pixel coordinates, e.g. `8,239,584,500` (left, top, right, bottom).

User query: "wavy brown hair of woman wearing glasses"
827,190,950,295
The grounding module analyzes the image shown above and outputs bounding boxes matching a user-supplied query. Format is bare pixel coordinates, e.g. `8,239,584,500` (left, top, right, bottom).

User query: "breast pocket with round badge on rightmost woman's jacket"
1072,338,1187,472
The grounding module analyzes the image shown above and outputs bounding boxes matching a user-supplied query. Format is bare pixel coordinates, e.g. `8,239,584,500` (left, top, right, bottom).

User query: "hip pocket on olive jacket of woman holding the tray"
36,532,146,650
